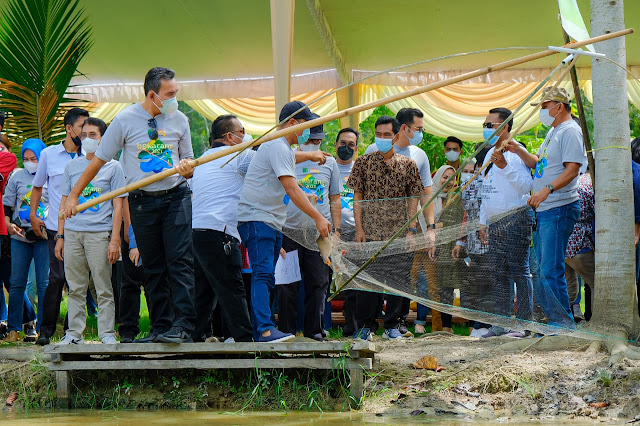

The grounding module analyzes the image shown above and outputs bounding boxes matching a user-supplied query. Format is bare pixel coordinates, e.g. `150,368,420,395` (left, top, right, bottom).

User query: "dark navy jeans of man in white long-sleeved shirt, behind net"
487,209,533,321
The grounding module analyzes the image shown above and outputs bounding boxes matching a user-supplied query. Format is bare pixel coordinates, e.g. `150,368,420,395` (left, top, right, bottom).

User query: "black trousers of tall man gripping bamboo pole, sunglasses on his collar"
129,183,195,333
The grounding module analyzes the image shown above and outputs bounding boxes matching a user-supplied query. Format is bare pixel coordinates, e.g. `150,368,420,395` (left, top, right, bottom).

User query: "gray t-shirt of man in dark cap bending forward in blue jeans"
238,138,296,231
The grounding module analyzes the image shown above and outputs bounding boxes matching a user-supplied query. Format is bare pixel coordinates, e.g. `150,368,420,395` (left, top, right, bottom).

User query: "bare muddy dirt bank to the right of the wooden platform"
362,334,640,423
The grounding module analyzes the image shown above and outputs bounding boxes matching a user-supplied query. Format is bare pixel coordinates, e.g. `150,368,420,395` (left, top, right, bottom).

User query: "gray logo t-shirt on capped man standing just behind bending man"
284,157,342,229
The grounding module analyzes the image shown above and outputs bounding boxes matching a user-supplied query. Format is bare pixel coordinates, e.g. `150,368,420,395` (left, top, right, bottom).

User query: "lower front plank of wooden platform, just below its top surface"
49,358,373,373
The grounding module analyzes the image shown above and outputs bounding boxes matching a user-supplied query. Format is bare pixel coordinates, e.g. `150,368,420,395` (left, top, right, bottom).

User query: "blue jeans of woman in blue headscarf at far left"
8,239,49,331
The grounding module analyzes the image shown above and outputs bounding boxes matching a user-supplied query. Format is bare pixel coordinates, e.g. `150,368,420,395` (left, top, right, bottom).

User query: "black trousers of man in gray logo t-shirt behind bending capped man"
276,236,331,337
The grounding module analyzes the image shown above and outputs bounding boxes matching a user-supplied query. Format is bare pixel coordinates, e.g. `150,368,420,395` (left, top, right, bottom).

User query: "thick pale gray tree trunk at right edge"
591,0,639,338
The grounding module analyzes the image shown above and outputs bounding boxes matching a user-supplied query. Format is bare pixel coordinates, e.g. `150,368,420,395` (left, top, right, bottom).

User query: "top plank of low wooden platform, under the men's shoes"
44,340,376,357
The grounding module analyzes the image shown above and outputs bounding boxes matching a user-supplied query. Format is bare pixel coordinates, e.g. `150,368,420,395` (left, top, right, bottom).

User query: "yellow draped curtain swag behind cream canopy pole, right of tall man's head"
185,90,338,135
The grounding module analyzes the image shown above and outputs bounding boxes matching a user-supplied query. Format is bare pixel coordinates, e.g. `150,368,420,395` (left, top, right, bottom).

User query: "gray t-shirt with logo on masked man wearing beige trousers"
60,157,127,232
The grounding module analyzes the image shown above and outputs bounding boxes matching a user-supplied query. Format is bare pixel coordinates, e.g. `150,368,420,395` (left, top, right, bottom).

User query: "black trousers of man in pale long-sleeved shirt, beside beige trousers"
40,229,67,337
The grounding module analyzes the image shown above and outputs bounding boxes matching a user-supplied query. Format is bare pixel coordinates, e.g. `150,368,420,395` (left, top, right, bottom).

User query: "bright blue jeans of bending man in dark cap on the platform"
238,222,282,340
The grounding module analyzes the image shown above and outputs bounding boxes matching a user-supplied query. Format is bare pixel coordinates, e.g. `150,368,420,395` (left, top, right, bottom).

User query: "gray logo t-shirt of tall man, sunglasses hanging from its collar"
96,103,193,191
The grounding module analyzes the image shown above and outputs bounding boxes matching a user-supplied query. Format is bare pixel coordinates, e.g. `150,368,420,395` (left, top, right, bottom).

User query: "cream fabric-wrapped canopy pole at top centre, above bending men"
271,0,295,115
